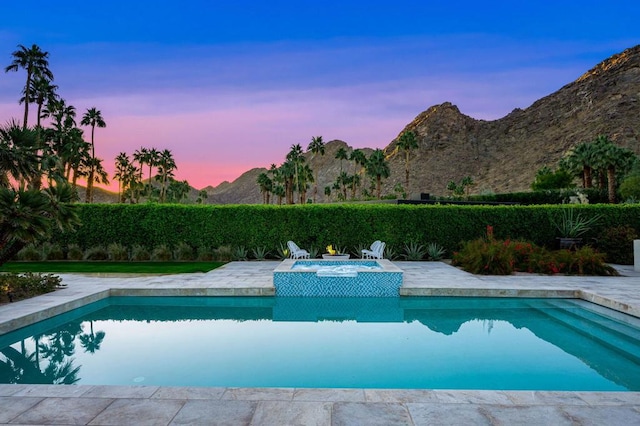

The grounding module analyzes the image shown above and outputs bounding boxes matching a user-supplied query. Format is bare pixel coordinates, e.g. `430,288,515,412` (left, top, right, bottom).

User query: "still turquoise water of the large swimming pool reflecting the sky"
0,297,640,391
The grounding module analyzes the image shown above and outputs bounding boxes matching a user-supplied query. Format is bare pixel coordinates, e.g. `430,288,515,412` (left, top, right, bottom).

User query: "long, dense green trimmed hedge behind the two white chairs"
52,204,640,253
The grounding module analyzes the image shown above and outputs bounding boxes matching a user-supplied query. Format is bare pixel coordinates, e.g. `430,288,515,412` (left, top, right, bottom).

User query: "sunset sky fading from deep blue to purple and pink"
0,0,640,189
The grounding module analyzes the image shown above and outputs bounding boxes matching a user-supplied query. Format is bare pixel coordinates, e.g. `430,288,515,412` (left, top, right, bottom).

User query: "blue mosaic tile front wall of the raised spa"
273,272,402,297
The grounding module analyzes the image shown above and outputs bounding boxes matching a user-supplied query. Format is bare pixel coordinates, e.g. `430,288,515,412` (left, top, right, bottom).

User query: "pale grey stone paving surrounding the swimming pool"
0,262,640,425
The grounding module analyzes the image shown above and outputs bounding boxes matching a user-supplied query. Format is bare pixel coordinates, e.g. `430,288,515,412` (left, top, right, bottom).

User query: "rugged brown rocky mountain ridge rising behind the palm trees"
206,45,640,203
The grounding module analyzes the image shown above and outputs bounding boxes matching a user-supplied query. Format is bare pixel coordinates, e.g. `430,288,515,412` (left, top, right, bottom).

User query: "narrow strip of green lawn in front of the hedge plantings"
0,261,224,274
